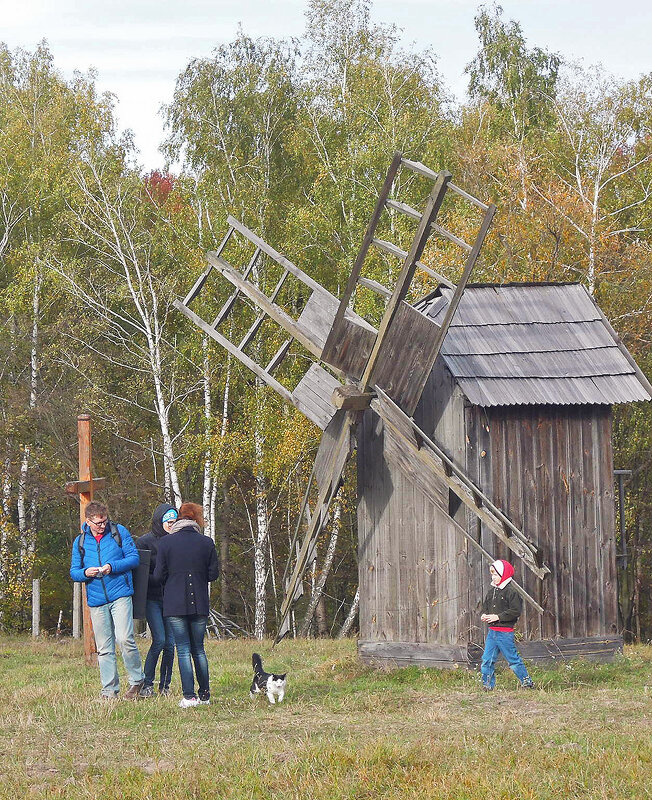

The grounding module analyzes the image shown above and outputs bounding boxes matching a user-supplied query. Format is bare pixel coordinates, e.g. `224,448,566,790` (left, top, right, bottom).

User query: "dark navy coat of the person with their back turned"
154,527,220,617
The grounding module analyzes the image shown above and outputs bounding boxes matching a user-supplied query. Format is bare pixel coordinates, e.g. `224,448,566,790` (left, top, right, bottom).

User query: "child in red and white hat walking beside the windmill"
480,559,534,691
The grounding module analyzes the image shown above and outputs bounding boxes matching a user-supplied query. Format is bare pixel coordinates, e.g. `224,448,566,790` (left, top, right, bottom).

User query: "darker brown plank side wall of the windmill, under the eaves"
466,406,618,639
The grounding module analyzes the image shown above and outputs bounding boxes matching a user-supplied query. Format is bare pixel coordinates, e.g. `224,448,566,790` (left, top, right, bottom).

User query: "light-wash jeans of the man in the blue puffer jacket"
89,597,143,697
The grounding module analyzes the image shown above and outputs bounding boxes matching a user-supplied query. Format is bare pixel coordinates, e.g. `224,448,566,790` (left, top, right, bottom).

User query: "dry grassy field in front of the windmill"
0,638,652,800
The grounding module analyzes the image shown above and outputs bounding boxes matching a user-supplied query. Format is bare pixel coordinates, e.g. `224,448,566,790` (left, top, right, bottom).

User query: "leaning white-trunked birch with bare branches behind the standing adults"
54,159,192,505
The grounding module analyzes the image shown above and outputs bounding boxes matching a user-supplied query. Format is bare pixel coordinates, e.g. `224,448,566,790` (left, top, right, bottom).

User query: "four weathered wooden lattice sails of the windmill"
175,153,549,638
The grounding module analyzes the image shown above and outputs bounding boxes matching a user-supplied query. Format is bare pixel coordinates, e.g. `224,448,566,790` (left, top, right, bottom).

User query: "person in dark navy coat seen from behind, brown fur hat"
154,503,219,708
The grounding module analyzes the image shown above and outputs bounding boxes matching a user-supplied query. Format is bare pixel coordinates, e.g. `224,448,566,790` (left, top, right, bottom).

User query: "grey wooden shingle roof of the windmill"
416,284,652,406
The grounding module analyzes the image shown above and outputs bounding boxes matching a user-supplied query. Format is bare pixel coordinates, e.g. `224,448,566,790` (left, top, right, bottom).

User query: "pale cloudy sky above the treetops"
0,0,652,170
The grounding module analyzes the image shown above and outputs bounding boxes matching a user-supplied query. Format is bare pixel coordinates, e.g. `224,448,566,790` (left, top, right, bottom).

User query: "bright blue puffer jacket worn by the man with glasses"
70,523,140,607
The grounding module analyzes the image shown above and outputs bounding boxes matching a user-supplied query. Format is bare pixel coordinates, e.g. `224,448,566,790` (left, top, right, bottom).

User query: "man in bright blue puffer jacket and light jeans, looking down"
70,502,144,700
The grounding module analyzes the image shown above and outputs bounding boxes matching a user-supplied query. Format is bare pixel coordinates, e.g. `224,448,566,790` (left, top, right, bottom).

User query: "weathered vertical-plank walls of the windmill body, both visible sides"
358,366,618,660
